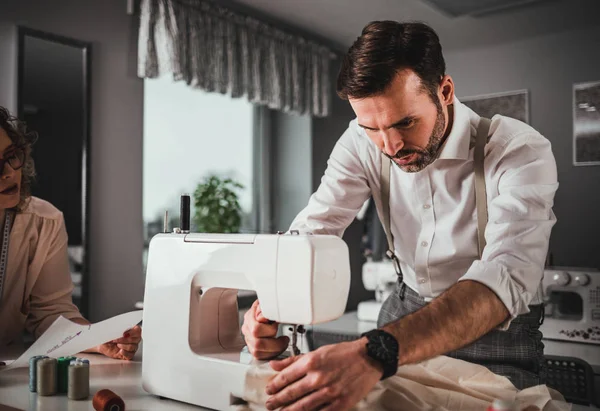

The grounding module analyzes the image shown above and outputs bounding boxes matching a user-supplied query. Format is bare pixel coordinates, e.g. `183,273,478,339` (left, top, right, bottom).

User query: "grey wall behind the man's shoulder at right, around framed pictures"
442,26,600,268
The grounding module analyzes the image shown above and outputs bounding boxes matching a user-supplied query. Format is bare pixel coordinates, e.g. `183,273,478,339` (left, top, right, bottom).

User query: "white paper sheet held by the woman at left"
0,310,143,372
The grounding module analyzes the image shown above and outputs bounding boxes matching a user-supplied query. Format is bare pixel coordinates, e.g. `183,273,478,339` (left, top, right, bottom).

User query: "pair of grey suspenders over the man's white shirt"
380,117,491,290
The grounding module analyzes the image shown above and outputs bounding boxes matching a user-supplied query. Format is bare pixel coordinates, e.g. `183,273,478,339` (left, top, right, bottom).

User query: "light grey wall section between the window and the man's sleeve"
269,110,313,231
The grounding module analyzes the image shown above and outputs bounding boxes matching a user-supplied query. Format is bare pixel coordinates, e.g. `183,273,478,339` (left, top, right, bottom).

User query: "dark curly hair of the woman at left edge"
0,106,38,211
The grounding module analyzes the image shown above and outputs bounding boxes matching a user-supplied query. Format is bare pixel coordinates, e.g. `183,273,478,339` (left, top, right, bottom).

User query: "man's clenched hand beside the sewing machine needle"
242,300,290,360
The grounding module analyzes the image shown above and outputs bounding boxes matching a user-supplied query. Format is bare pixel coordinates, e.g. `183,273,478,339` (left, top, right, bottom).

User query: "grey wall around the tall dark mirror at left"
0,0,143,321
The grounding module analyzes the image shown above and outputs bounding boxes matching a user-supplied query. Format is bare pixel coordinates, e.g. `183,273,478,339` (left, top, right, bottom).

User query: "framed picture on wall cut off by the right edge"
573,81,600,166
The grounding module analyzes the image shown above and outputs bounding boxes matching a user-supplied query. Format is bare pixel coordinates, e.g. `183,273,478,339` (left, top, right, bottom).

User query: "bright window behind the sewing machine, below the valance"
143,77,266,276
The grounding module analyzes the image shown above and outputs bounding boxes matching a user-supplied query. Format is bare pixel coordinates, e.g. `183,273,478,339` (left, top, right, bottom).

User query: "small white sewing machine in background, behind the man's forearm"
357,259,398,322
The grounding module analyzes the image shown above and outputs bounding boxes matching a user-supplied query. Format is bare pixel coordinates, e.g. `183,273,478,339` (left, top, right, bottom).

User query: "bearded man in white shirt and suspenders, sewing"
243,21,558,410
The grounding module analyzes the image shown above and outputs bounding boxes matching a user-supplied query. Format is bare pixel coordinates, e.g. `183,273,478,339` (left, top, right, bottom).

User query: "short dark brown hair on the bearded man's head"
337,21,446,104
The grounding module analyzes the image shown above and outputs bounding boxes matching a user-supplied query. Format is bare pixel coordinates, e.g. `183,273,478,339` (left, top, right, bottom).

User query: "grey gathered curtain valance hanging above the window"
138,0,335,117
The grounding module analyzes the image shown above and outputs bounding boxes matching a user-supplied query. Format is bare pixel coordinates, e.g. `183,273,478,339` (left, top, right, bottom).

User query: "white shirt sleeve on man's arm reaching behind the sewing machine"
290,127,371,237
